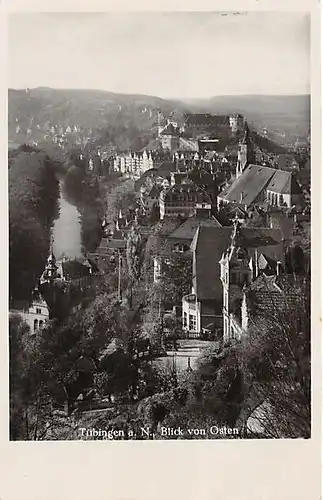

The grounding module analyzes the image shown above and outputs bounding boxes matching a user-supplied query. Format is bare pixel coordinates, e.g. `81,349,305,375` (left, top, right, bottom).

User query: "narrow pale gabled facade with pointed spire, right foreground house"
220,219,252,343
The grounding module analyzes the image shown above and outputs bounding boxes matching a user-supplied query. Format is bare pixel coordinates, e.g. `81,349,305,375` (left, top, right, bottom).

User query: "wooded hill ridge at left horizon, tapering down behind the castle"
8,87,189,135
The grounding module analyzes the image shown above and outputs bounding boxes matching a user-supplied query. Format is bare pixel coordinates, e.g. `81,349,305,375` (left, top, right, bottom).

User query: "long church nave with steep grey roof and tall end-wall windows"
217,164,302,210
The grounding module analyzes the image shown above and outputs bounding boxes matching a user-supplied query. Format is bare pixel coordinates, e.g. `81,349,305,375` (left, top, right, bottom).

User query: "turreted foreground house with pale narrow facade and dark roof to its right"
219,220,284,343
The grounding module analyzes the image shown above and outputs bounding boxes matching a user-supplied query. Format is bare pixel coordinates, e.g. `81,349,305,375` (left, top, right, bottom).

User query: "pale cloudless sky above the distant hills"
8,12,310,99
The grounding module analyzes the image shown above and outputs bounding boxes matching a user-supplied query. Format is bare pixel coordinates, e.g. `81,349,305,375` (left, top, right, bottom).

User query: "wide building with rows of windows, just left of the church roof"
159,182,212,219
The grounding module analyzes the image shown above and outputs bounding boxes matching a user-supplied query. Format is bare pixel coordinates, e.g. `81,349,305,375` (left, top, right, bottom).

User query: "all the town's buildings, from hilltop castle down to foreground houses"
10,111,310,350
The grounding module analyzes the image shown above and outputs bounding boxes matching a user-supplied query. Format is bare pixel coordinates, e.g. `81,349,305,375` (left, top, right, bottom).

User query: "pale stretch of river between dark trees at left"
52,179,82,259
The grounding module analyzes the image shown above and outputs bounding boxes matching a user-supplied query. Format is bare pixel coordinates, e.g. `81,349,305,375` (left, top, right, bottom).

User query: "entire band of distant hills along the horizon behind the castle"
8,87,310,149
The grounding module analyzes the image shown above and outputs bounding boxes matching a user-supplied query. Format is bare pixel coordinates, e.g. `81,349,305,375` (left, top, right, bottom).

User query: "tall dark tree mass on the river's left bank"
9,152,59,300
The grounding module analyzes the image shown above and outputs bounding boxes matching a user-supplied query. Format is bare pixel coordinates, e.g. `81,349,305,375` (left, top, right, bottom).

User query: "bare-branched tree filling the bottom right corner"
238,278,311,438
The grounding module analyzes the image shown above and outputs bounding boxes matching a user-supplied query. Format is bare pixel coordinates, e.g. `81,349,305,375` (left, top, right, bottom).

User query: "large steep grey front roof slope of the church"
219,164,277,206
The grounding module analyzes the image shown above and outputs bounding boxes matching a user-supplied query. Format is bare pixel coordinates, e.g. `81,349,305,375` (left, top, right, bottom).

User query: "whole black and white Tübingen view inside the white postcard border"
7,10,312,442
